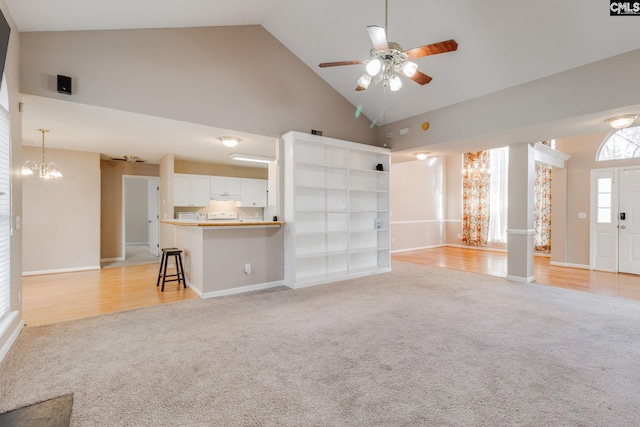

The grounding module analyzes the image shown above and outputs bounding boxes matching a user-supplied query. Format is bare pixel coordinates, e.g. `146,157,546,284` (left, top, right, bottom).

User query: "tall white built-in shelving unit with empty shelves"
282,132,391,288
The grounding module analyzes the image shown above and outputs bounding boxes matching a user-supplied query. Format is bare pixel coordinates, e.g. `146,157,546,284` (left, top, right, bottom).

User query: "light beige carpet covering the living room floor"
0,262,640,426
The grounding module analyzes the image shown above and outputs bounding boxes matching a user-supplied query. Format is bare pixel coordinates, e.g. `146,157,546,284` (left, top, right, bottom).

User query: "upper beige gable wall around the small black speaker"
20,25,376,144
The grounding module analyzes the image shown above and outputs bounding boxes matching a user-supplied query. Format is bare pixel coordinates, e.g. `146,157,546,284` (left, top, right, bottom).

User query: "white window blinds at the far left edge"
0,107,11,317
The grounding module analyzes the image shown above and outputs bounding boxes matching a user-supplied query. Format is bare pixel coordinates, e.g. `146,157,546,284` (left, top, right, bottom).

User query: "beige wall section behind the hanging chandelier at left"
22,146,100,274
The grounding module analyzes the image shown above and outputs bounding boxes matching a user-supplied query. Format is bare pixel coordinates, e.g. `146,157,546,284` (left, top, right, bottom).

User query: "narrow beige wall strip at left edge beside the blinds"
0,0,23,359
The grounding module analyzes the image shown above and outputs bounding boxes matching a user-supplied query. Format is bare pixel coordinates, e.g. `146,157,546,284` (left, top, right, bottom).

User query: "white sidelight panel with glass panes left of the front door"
591,169,618,272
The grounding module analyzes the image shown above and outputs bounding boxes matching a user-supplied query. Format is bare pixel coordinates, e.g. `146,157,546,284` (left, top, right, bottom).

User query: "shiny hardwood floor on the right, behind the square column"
392,247,640,300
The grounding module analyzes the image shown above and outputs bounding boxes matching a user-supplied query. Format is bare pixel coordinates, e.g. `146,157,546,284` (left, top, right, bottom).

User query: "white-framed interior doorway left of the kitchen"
121,175,160,264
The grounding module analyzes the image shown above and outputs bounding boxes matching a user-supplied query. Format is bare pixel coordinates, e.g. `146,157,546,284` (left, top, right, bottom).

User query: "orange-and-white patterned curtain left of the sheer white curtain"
462,150,491,246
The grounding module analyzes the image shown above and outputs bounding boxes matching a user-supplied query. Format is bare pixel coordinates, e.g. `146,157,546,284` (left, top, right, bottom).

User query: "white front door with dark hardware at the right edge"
617,169,640,274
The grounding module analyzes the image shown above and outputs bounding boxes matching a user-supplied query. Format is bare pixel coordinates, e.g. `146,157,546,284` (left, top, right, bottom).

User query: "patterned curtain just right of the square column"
533,165,551,253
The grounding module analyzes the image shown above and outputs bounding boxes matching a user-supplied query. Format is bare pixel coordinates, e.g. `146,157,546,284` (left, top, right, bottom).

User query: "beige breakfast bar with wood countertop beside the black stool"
161,220,284,298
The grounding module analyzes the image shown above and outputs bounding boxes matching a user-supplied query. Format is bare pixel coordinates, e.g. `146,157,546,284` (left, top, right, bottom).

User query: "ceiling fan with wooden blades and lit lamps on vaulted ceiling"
320,0,458,91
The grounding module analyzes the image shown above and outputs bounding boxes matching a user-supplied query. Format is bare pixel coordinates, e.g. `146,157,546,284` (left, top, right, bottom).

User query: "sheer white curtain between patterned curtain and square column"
489,147,509,242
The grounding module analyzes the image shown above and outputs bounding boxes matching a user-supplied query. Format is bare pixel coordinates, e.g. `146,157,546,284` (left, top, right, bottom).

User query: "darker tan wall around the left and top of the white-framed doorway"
98,160,160,259
